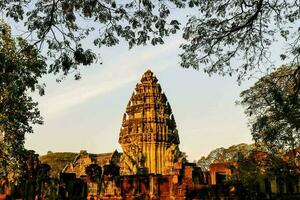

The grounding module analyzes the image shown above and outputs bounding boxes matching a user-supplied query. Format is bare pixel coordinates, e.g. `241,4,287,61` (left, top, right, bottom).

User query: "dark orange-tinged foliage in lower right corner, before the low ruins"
226,149,299,199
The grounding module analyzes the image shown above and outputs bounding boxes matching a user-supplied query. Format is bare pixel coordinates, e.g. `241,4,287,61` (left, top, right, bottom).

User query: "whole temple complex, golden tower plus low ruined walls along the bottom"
0,70,300,200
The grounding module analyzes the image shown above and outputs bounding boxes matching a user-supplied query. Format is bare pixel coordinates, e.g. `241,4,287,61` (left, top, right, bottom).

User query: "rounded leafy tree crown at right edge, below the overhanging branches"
240,65,300,155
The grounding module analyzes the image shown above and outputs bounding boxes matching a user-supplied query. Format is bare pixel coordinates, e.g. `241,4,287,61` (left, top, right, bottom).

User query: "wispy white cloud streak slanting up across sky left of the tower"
34,40,180,119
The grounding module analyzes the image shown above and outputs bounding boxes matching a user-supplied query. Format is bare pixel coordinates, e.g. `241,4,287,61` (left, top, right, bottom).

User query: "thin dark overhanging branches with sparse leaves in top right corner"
180,0,300,81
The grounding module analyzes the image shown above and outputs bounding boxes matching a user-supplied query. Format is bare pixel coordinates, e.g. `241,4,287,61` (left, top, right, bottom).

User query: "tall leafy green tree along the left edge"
0,21,46,182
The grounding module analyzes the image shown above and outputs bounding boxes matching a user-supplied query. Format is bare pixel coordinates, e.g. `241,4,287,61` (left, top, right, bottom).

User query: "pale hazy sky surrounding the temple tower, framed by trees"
18,6,290,161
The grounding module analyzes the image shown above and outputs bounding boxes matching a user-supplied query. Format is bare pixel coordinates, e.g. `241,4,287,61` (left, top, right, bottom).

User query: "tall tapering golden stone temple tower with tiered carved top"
119,70,179,175
